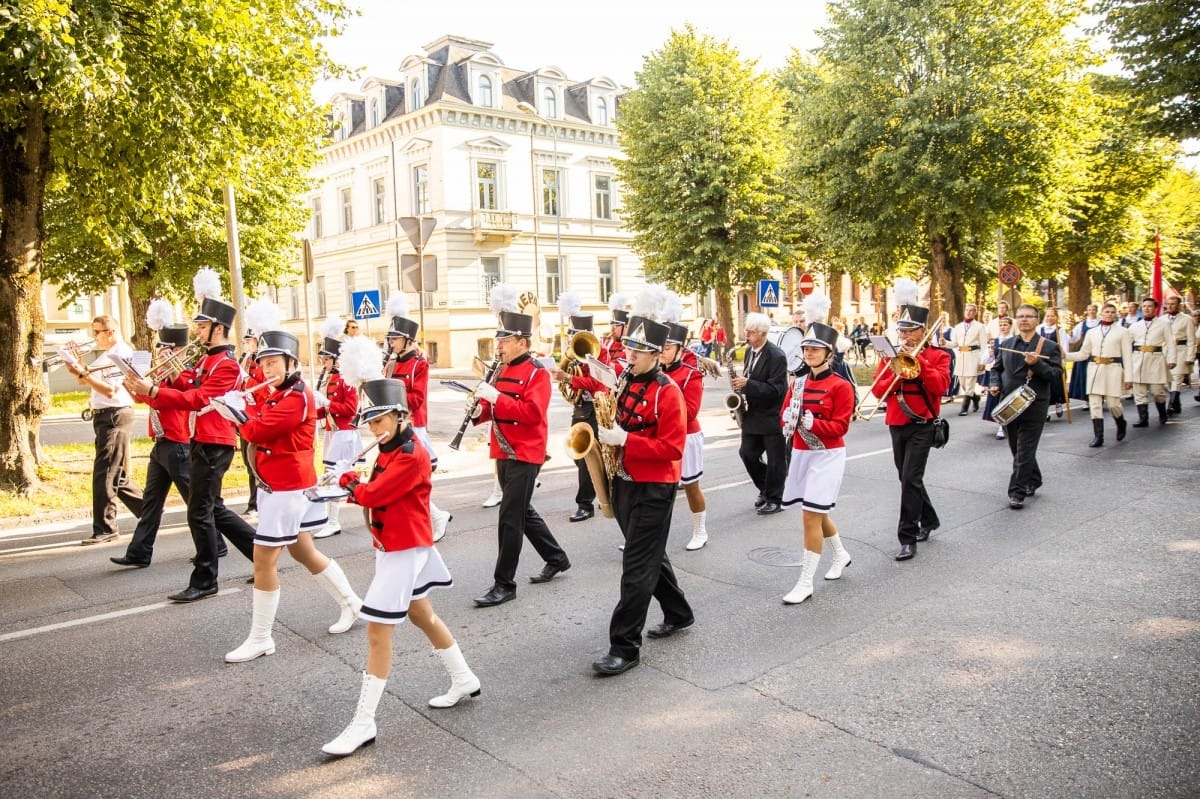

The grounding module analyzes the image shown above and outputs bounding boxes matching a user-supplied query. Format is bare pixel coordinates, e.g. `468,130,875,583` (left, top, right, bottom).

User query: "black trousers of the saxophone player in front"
608,475,696,660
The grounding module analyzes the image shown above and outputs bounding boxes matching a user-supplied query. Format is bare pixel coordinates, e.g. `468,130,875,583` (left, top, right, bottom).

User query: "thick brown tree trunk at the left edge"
0,102,50,494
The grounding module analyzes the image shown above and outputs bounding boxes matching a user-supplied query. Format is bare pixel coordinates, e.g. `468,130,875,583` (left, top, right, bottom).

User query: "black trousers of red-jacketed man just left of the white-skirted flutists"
187,441,254,590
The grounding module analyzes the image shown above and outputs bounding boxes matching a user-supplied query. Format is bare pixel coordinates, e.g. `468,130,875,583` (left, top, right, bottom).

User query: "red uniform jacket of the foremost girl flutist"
350,427,433,552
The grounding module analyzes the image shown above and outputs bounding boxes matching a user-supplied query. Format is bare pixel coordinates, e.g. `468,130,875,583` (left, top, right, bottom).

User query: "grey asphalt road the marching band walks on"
0,379,1200,798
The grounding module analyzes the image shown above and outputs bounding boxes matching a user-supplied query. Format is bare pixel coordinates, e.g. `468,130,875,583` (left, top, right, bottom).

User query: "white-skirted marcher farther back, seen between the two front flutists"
312,314,357,539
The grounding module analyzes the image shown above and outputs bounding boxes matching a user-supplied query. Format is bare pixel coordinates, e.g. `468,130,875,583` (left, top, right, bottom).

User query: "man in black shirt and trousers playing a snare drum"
990,305,1062,510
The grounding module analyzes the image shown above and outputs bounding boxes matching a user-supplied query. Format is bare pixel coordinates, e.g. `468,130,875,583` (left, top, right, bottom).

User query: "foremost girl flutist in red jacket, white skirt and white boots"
322,380,480,756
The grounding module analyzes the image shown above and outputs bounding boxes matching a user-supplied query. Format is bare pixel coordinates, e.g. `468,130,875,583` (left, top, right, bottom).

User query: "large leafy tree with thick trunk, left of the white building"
0,0,347,491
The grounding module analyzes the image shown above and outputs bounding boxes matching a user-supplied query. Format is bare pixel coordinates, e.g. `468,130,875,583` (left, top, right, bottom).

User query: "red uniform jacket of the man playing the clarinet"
475,353,550,465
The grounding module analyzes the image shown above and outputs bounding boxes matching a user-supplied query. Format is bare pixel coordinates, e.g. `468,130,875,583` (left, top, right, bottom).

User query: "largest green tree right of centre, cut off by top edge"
790,0,1087,318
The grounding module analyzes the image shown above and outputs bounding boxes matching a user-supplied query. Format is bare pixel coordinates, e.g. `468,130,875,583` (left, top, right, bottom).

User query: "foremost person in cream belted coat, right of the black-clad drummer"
1067,302,1133,446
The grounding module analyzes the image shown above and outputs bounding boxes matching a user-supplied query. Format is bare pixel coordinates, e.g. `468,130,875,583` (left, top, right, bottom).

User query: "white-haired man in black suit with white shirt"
733,313,787,516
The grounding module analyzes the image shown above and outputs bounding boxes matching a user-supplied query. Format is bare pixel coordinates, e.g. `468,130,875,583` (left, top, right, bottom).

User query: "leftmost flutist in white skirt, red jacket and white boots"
212,307,362,663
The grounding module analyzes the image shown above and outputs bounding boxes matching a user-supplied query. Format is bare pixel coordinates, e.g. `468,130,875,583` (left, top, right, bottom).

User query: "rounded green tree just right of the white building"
617,26,791,332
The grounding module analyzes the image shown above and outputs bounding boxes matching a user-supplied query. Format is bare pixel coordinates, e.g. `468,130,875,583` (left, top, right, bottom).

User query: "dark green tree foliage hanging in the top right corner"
1096,0,1200,142
